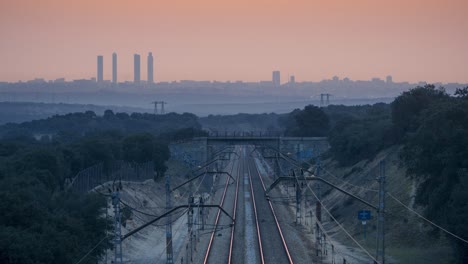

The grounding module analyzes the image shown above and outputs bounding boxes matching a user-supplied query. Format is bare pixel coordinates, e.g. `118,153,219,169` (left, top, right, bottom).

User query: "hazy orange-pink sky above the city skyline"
0,0,468,83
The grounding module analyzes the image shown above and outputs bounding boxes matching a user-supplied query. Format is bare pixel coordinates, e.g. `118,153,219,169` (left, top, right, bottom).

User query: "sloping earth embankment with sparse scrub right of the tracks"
321,146,456,264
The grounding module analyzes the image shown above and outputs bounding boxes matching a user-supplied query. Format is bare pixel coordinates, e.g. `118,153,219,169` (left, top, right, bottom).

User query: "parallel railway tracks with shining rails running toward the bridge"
203,146,294,264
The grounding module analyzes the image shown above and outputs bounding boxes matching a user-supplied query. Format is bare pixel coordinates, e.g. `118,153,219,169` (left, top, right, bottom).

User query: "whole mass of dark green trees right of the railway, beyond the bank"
296,85,468,263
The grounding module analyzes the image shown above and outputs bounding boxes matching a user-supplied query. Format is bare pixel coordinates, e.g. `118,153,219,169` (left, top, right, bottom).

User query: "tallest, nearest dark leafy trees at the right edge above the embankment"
392,87,468,263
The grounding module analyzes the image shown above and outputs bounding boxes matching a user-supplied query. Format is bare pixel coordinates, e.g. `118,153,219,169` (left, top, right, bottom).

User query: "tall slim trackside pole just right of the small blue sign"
375,160,385,264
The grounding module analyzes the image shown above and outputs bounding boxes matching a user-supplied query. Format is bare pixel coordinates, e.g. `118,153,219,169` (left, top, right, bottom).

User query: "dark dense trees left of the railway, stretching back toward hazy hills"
0,112,207,263
